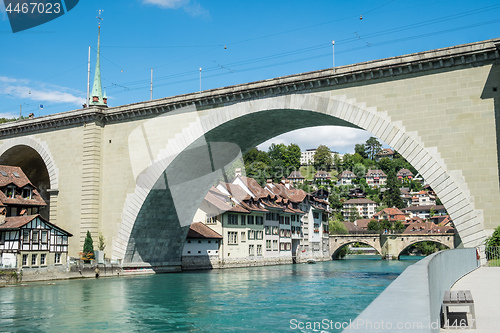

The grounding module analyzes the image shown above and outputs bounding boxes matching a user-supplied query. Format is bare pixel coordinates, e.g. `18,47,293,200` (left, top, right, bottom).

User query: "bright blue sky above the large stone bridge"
0,0,500,153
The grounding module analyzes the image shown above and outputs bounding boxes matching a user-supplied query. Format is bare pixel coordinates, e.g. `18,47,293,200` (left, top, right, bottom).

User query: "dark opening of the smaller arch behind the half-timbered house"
0,145,50,220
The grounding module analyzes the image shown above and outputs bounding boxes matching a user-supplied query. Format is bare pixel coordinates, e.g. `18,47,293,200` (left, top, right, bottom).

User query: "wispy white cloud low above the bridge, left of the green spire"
0,76,85,106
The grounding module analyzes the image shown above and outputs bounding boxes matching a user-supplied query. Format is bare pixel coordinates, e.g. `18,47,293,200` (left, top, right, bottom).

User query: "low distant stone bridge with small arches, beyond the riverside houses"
330,234,455,259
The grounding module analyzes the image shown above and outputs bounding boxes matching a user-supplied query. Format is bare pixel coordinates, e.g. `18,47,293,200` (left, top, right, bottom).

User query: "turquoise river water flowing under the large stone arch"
0,256,422,333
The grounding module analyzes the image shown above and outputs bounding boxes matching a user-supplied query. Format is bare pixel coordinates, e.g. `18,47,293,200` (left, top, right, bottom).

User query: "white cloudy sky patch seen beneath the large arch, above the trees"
258,126,385,154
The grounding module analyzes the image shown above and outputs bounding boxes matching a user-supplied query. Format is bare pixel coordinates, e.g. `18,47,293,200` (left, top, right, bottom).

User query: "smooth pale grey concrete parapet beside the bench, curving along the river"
344,248,479,332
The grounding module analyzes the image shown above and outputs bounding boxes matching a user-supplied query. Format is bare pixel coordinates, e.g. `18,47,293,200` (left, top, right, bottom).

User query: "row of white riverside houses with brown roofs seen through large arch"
182,170,330,269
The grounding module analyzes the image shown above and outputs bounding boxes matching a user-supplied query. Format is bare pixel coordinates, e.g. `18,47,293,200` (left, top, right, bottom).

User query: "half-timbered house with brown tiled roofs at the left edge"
0,165,72,274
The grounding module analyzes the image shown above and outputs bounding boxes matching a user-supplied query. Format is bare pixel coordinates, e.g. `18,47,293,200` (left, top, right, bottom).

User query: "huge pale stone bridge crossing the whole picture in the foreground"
0,39,500,268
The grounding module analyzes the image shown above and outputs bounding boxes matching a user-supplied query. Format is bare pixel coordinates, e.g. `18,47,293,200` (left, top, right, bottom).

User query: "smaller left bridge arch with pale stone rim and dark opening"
0,136,59,218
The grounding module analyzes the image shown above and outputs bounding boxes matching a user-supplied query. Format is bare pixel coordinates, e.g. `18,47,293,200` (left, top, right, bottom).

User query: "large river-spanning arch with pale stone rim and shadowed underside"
113,91,485,265
